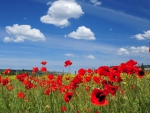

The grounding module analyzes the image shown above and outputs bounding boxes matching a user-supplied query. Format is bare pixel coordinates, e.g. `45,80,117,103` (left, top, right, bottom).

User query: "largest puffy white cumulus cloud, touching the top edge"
40,0,84,28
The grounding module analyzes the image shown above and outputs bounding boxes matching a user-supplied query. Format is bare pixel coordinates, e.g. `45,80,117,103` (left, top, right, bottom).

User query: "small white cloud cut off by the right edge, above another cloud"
133,30,150,40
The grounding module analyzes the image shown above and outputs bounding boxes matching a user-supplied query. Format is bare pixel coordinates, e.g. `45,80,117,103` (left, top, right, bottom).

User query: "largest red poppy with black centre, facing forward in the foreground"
91,89,108,106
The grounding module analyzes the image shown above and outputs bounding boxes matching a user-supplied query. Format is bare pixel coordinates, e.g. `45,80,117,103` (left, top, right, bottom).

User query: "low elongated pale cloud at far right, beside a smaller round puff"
130,46,148,53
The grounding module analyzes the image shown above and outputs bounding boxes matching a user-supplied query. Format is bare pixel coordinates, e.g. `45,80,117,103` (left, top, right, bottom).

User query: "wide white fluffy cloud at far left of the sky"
4,24,45,42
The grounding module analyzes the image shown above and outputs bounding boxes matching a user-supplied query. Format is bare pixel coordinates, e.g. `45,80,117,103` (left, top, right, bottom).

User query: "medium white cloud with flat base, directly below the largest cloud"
65,26,96,40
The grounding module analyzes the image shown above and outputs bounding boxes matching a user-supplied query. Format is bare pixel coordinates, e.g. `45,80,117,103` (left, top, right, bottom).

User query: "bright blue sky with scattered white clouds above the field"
0,0,150,73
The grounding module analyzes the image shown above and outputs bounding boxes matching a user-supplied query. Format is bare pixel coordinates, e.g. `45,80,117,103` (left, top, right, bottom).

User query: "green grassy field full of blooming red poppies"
0,59,150,113
